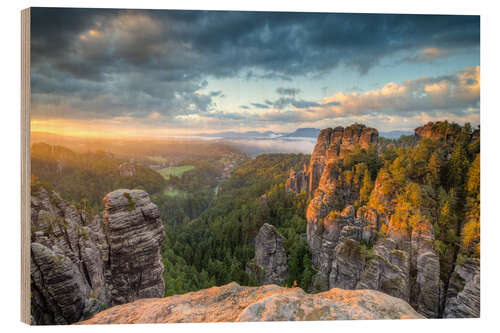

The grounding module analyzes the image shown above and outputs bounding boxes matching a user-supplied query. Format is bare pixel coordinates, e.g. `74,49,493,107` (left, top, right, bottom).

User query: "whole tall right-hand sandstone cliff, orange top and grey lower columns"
287,125,458,318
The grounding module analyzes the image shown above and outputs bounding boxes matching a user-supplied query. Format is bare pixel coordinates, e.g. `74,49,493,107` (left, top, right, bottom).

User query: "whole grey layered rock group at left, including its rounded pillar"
31,187,164,325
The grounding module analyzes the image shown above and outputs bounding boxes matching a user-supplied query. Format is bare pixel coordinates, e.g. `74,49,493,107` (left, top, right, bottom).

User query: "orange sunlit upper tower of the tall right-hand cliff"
286,124,378,195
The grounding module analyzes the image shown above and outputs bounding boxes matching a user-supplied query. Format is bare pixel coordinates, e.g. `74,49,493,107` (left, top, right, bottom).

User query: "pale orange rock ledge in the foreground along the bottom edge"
78,282,424,324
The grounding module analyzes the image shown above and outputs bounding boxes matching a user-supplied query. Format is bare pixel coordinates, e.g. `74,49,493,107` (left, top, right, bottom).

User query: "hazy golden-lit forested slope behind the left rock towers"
31,143,166,212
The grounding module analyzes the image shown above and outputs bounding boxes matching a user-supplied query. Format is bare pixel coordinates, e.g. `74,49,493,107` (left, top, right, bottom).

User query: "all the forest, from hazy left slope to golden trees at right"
32,122,480,296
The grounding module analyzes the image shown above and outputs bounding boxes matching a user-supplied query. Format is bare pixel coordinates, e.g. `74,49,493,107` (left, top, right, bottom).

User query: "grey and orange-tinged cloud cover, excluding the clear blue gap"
31,8,479,131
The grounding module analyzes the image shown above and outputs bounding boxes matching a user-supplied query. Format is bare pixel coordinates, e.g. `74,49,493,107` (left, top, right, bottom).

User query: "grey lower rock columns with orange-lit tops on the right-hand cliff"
307,180,442,318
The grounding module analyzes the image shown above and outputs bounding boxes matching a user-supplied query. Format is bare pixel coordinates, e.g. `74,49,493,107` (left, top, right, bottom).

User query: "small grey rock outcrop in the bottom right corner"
443,258,481,318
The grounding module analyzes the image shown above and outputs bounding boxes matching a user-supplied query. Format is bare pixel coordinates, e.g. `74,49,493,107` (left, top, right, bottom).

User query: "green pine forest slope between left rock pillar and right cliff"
159,154,314,295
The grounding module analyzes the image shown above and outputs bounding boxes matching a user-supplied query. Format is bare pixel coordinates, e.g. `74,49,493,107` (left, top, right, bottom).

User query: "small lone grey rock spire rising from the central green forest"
247,223,288,285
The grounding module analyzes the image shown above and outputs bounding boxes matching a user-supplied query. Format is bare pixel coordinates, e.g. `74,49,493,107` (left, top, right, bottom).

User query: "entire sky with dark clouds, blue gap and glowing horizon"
31,8,480,136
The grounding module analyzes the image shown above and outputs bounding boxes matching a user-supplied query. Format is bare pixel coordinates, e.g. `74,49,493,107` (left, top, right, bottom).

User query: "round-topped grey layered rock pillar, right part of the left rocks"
104,190,165,305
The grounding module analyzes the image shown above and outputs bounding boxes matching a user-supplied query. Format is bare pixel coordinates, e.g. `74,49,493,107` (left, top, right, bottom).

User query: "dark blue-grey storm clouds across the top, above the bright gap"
31,8,479,118
